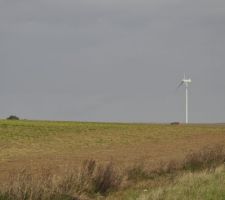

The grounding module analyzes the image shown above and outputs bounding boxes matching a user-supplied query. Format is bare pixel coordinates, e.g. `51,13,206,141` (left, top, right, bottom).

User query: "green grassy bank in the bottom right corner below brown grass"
107,166,225,200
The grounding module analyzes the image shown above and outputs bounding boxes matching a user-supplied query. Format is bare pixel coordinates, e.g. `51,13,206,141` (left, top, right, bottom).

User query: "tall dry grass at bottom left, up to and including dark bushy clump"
0,160,122,200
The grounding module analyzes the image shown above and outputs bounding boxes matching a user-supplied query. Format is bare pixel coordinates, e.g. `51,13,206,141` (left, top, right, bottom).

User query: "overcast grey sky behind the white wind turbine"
0,0,225,122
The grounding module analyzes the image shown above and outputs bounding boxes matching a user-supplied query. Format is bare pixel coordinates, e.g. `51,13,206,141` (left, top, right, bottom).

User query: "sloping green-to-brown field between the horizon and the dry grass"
0,120,225,178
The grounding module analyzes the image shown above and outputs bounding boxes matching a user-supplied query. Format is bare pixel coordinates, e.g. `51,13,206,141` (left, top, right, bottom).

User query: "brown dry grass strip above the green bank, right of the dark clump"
127,145,225,181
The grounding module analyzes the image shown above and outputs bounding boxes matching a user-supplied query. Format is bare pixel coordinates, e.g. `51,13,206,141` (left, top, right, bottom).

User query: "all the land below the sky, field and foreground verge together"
0,120,225,200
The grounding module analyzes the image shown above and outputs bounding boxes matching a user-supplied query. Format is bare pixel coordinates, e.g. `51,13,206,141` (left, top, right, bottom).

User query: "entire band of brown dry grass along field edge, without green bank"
0,146,225,200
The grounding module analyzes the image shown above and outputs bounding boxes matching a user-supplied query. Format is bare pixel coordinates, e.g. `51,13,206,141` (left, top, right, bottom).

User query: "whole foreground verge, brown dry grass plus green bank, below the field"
0,146,225,200
